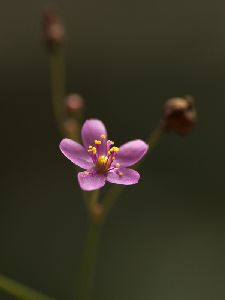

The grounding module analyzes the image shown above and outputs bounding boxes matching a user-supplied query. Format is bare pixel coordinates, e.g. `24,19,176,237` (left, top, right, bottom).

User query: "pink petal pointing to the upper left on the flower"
59,139,93,169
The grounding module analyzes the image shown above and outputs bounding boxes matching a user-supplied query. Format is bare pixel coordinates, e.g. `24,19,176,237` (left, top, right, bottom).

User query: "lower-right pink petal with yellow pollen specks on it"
106,168,140,185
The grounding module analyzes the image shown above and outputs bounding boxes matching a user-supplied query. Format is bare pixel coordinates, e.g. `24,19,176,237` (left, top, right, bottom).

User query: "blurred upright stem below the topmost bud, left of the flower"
49,47,65,133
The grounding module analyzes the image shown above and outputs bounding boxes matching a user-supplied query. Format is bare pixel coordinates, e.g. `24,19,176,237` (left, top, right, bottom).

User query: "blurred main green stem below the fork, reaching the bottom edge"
75,218,102,300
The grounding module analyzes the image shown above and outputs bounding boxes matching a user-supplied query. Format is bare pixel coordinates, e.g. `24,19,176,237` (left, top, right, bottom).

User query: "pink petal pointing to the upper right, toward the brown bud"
114,140,148,167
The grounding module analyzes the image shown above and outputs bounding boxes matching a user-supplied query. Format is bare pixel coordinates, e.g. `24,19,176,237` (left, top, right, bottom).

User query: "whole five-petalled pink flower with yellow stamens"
60,119,148,191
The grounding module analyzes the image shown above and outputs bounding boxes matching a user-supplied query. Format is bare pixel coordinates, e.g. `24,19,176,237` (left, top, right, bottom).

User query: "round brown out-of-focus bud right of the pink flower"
162,96,197,135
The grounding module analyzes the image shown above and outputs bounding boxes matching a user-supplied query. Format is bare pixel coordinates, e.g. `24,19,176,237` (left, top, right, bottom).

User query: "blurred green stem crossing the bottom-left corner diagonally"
0,275,53,300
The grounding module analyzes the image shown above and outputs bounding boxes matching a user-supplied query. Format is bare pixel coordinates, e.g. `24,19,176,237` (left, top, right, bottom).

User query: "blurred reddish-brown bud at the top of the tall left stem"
43,7,65,49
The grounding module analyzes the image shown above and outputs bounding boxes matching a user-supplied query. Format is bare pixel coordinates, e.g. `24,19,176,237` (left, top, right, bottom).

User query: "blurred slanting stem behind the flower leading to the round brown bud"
102,126,163,219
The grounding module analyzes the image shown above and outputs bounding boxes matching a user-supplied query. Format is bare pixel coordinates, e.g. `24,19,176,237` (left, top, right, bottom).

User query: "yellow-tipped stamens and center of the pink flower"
88,134,120,173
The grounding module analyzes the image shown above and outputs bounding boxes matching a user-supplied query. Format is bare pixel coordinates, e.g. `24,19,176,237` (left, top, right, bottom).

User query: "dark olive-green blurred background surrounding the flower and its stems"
0,0,225,300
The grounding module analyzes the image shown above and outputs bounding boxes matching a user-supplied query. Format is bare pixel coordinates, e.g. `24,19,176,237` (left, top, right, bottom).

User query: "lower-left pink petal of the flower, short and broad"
77,171,106,191
